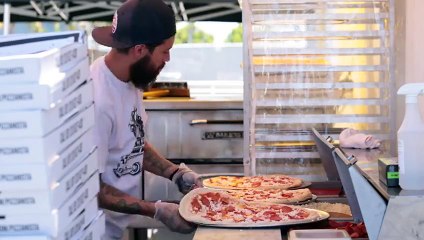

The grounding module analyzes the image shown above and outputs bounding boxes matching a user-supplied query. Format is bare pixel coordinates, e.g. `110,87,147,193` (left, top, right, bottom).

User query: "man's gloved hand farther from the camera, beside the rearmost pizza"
172,163,203,194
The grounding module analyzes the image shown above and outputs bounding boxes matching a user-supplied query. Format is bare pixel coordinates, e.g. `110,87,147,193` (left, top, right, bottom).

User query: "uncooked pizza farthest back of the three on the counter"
203,175,303,189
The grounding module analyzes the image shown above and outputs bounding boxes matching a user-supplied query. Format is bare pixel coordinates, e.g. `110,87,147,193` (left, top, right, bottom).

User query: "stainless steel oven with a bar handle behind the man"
144,99,243,200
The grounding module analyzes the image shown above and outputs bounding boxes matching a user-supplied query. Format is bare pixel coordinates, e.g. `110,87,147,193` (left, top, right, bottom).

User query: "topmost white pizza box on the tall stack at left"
0,31,87,56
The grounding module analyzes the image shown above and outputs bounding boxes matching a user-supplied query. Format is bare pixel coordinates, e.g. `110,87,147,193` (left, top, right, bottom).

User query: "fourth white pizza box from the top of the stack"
0,81,94,138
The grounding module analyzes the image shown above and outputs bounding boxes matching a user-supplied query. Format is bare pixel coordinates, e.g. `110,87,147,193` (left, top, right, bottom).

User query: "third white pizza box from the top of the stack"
0,58,90,110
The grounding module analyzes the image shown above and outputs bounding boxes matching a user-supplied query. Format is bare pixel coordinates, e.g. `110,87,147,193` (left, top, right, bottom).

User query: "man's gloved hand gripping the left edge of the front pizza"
154,201,196,233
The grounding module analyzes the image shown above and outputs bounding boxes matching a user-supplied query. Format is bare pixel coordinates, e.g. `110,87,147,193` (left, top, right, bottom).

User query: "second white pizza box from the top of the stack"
0,43,88,85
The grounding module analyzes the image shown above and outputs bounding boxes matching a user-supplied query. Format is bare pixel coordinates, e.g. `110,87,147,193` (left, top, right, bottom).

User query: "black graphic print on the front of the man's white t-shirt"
113,108,144,178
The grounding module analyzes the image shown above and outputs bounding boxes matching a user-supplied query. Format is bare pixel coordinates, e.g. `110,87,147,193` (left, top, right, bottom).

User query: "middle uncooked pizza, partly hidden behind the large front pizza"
227,188,312,204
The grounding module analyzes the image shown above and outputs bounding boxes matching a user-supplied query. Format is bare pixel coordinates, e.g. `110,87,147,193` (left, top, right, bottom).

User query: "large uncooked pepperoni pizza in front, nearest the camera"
180,188,328,227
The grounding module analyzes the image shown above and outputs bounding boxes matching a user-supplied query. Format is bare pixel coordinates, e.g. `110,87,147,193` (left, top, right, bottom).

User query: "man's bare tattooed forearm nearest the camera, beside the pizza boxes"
98,176,155,217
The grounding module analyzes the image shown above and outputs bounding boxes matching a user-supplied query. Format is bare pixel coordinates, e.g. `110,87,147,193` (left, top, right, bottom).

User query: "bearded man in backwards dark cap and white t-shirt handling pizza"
91,0,201,239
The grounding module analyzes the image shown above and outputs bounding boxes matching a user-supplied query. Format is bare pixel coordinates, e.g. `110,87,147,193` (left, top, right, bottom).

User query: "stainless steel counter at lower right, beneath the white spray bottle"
342,149,424,240
